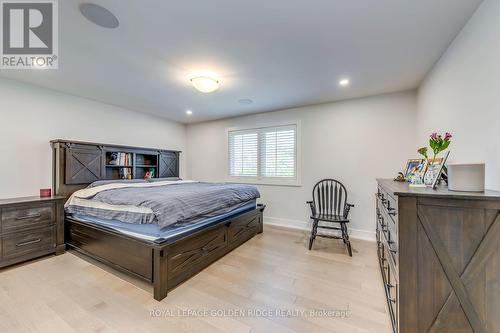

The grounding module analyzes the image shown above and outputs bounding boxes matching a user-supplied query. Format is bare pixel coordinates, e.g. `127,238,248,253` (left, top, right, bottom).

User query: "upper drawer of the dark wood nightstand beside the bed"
1,203,56,233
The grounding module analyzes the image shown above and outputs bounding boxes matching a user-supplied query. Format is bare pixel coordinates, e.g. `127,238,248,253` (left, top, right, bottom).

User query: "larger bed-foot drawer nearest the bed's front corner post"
167,225,227,288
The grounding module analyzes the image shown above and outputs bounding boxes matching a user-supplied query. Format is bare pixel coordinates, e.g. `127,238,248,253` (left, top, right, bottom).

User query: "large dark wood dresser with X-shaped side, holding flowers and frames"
376,179,500,333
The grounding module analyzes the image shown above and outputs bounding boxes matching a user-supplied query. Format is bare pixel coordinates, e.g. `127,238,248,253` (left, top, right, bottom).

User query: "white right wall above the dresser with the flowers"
417,0,500,190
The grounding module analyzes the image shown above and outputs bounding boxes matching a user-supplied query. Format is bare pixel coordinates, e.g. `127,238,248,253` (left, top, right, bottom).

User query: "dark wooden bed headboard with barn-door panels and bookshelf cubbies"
50,140,181,196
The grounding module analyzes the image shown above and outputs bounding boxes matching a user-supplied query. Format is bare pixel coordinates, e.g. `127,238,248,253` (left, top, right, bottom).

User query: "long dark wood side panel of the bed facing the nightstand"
66,222,153,281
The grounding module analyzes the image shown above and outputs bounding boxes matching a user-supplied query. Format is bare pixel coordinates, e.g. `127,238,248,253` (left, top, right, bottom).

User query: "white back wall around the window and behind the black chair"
187,92,416,238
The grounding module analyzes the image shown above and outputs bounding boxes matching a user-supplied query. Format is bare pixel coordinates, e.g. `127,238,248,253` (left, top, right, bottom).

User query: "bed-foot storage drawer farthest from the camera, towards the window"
227,209,262,248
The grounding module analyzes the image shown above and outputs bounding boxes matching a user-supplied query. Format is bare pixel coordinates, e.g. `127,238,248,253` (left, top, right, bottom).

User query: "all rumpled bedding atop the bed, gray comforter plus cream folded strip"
65,180,260,228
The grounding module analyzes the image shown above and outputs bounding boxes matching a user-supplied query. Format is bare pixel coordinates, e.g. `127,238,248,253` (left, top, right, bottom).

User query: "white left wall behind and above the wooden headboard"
0,79,185,198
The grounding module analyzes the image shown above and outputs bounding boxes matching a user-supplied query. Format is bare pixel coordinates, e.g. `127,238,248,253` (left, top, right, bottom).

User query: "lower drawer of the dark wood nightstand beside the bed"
2,227,56,259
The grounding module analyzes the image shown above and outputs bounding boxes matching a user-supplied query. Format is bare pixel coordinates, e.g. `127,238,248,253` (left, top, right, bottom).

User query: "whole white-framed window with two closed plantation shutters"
228,124,297,184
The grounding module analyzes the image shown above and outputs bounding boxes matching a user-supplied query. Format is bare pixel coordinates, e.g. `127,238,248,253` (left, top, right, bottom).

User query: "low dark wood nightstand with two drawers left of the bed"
0,197,65,268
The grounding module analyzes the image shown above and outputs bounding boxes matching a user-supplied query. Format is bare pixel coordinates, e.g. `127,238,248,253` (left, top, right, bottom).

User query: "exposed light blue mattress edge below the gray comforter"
72,200,257,242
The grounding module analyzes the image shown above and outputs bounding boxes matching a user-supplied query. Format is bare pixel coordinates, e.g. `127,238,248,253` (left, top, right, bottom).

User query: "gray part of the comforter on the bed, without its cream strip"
66,182,260,228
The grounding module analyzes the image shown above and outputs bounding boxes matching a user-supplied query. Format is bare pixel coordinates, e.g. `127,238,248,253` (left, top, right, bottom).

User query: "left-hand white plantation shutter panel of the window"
229,131,258,177
